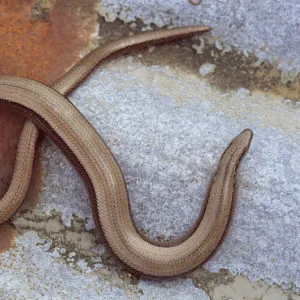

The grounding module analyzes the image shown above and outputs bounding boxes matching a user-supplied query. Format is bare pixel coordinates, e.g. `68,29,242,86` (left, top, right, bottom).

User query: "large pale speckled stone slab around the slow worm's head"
34,58,300,287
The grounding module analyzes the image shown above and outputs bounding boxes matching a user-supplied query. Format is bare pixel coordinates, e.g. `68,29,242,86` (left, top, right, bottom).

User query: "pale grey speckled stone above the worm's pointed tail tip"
99,0,300,74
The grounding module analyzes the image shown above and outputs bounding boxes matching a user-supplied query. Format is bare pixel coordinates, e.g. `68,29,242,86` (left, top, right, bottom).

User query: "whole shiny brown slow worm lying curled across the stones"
0,27,252,277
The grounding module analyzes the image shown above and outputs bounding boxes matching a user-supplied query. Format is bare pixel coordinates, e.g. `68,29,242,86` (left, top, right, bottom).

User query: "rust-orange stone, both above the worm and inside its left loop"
0,0,97,202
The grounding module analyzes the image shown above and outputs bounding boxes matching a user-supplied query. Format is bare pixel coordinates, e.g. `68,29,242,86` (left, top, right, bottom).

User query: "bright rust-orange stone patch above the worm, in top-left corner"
0,0,96,84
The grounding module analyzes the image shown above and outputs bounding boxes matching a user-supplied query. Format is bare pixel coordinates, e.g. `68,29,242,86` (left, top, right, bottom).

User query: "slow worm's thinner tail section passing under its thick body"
0,26,210,224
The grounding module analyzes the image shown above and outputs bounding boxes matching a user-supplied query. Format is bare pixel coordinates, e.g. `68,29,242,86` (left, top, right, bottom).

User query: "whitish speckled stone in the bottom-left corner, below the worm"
0,232,129,300
